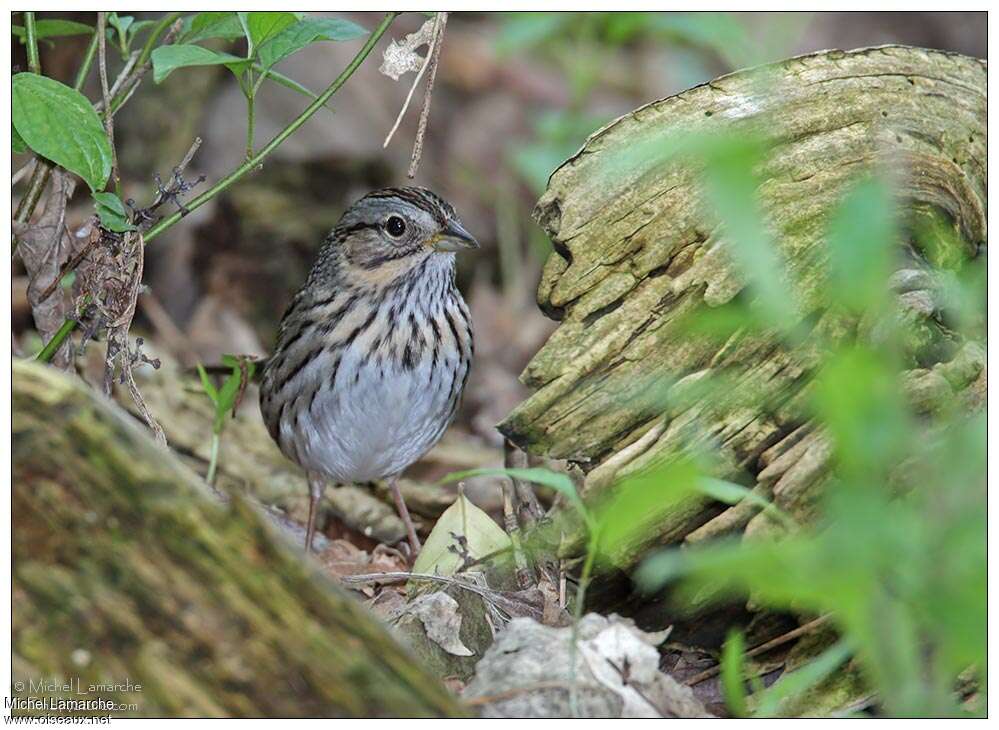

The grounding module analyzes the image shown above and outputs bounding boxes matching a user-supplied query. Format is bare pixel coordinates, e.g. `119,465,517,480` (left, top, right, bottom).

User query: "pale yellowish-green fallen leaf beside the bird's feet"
413,494,510,576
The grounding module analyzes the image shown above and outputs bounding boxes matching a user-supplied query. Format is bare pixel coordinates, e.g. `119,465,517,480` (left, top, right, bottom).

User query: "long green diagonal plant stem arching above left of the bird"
38,12,399,362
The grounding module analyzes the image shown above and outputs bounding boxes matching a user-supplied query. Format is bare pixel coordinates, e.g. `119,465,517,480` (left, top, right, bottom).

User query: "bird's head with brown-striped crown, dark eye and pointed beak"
334,187,479,280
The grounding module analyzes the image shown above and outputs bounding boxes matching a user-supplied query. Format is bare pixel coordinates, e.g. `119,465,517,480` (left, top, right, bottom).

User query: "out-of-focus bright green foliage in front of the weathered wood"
636,139,986,716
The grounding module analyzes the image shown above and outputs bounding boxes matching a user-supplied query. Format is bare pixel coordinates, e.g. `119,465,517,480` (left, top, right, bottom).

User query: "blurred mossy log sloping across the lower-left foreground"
12,360,462,717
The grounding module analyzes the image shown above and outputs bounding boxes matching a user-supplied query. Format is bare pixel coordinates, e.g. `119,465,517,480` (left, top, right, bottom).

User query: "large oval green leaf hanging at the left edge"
11,72,111,192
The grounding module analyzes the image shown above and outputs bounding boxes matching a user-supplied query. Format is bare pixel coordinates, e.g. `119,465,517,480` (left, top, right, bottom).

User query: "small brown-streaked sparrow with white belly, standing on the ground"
260,188,477,552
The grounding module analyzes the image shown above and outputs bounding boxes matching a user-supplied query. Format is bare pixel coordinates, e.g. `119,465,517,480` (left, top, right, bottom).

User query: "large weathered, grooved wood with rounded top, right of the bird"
500,47,986,564
